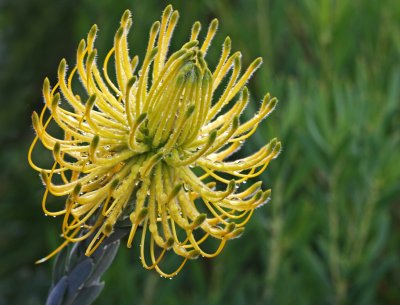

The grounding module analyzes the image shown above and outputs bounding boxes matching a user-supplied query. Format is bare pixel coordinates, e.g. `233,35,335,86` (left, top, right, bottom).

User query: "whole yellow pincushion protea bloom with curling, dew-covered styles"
29,6,280,276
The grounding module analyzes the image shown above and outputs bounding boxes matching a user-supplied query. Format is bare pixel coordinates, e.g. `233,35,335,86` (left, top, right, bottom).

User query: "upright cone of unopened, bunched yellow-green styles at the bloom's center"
129,49,211,155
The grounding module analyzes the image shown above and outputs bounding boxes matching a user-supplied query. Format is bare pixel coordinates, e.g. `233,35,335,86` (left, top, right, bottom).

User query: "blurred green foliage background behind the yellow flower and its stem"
0,0,400,305
